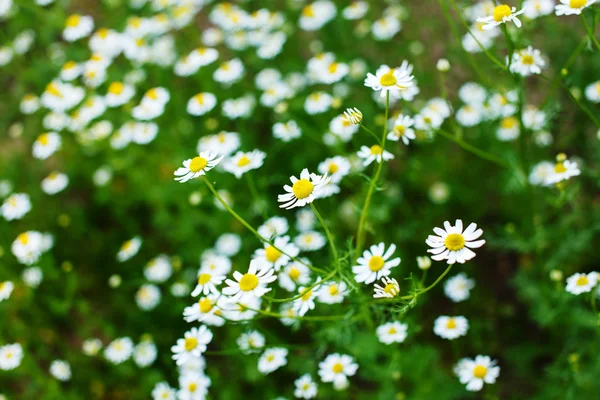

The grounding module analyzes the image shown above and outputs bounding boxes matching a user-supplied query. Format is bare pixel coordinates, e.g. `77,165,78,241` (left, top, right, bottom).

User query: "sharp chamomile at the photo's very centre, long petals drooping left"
277,168,330,210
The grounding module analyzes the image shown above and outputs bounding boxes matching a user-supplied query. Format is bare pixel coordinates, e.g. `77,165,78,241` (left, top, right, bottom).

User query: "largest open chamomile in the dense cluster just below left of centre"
223,260,277,302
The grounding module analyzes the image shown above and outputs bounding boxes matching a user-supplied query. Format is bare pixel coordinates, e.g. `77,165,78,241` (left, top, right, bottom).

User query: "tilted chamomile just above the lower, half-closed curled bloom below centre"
352,242,400,285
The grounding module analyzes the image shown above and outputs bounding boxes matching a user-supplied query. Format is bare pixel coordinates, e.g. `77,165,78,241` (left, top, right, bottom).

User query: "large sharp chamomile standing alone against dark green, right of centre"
425,219,485,264
